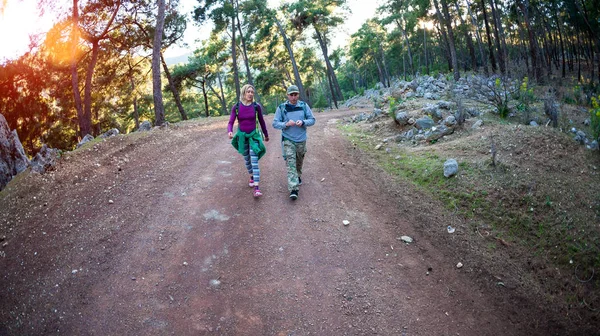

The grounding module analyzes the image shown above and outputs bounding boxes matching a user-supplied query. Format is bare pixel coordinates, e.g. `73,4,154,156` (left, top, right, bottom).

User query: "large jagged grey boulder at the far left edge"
0,114,30,190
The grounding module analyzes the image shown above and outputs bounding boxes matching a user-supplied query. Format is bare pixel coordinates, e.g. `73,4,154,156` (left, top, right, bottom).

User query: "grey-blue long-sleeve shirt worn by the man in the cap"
273,101,316,142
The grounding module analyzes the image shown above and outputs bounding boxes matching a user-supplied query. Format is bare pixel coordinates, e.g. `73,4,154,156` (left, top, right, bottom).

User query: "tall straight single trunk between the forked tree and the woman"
152,0,165,126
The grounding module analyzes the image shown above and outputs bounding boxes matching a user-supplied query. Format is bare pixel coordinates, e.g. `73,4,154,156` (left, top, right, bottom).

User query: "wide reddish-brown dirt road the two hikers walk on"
0,110,564,335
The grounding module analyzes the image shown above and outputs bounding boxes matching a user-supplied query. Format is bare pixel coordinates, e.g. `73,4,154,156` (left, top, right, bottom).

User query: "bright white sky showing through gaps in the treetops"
0,0,380,63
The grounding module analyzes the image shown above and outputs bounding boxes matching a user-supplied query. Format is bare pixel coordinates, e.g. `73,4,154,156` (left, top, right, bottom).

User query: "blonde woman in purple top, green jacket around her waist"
227,84,269,197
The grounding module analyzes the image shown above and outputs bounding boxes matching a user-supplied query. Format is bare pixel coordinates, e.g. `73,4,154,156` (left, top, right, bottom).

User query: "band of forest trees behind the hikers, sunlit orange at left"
0,0,600,155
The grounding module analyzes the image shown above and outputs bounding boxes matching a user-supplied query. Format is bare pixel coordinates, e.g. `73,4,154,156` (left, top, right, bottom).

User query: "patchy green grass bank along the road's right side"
340,120,600,280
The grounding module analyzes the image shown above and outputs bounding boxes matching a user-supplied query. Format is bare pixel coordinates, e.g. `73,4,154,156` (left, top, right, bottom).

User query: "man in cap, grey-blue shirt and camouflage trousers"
273,85,315,200
